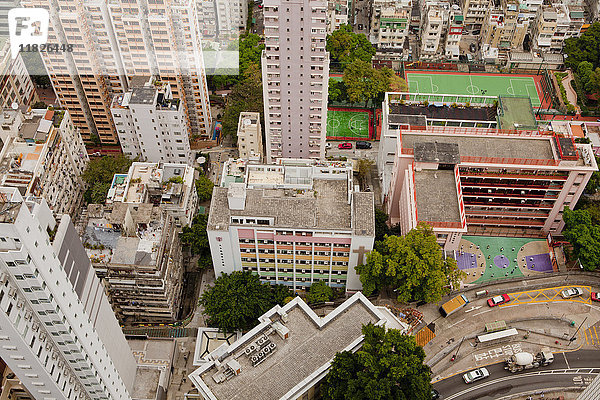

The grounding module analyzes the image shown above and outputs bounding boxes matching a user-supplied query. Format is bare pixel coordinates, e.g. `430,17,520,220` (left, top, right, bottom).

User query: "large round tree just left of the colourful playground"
356,223,462,303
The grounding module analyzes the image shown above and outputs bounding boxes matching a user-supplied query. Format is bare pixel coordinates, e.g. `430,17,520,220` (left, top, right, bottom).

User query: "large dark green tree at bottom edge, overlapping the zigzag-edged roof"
321,324,431,400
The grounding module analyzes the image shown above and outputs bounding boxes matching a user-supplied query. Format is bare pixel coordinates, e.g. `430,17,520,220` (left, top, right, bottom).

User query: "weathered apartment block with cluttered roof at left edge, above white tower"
0,109,89,215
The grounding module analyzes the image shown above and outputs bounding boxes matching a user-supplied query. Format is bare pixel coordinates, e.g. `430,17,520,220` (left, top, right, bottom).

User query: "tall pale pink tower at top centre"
262,0,329,163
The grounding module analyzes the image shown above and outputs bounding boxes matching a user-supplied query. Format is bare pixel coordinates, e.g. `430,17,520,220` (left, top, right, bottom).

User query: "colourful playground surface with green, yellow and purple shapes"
456,236,554,283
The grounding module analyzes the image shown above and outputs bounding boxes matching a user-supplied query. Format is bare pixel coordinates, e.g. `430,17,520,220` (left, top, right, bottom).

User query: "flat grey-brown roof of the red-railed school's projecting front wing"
414,169,461,223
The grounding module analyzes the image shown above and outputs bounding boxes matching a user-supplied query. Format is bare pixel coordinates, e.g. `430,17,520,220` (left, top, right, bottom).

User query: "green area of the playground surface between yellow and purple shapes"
463,236,544,283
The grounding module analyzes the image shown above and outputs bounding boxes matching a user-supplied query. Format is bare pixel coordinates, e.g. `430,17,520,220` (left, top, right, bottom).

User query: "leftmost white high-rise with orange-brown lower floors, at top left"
22,0,127,144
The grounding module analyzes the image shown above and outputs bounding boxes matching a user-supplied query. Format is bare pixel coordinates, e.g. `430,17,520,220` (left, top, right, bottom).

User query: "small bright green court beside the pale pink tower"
327,107,373,140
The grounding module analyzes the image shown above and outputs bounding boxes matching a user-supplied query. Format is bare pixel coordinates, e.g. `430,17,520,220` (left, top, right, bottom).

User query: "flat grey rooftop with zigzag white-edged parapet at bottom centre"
190,292,406,400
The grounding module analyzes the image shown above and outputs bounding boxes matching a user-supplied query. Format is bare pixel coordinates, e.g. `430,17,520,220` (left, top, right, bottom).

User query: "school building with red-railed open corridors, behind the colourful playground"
380,96,598,245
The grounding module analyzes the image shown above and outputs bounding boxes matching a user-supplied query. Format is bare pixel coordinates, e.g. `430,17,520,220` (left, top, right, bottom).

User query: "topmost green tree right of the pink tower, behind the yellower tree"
325,25,376,71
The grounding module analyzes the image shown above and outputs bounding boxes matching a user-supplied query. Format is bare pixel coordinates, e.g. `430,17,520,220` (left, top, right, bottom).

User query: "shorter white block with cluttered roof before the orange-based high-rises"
111,78,194,164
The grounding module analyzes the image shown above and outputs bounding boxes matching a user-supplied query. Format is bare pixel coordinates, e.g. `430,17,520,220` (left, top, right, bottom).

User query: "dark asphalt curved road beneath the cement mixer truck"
433,350,600,400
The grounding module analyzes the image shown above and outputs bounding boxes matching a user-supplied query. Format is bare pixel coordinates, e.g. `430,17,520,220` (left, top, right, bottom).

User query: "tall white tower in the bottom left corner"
0,187,136,400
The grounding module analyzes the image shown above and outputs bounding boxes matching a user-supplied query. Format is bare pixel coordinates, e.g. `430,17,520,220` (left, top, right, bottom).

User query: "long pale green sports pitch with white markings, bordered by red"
406,72,541,107
